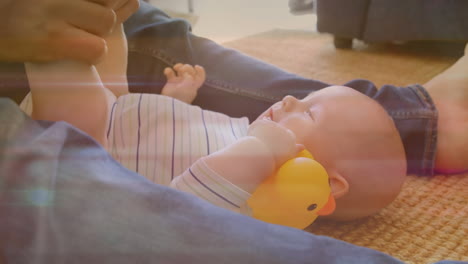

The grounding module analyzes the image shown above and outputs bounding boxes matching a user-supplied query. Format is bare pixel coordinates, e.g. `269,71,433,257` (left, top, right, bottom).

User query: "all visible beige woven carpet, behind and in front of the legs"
225,30,468,263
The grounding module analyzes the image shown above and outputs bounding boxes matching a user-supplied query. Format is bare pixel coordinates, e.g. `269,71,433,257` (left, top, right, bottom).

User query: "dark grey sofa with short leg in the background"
316,0,468,48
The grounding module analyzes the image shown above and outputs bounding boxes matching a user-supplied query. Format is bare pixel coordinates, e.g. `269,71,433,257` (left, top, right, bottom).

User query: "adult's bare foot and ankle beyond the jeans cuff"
424,44,468,173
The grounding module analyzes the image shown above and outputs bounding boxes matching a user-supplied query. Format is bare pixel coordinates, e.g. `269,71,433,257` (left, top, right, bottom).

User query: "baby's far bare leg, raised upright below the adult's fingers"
96,24,128,97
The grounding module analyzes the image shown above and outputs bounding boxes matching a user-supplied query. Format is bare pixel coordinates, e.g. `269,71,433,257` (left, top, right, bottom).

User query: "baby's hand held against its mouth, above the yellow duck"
247,119,304,168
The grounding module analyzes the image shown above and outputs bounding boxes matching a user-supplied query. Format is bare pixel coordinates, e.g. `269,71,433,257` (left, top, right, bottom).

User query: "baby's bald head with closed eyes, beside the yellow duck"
260,86,406,220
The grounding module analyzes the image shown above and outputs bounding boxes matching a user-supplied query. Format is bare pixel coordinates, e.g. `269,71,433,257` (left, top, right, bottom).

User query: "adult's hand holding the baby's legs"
0,0,139,64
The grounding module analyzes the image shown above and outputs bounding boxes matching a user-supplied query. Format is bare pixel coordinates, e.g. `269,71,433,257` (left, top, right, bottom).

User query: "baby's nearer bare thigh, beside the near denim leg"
26,61,115,146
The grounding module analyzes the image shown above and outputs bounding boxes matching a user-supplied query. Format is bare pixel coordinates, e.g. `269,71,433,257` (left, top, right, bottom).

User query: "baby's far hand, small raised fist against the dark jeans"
161,63,206,104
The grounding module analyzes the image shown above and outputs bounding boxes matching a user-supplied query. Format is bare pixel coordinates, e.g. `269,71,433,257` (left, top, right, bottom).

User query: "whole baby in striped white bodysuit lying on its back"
22,21,406,223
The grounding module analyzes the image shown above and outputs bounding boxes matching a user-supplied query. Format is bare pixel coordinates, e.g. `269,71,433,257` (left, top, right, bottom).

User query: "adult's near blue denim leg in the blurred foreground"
0,98,461,264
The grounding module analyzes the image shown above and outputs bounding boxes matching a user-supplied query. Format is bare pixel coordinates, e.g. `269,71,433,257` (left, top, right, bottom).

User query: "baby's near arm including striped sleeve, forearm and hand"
171,120,300,211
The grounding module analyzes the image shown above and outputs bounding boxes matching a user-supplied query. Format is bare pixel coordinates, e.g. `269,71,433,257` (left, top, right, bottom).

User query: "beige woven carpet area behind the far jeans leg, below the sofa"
224,30,463,86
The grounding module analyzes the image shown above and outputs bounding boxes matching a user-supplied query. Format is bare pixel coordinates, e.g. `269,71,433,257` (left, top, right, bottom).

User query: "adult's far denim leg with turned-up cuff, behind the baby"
125,2,437,175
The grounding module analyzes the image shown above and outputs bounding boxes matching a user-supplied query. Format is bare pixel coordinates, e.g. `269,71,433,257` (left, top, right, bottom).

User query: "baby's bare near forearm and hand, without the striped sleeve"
205,120,298,193
